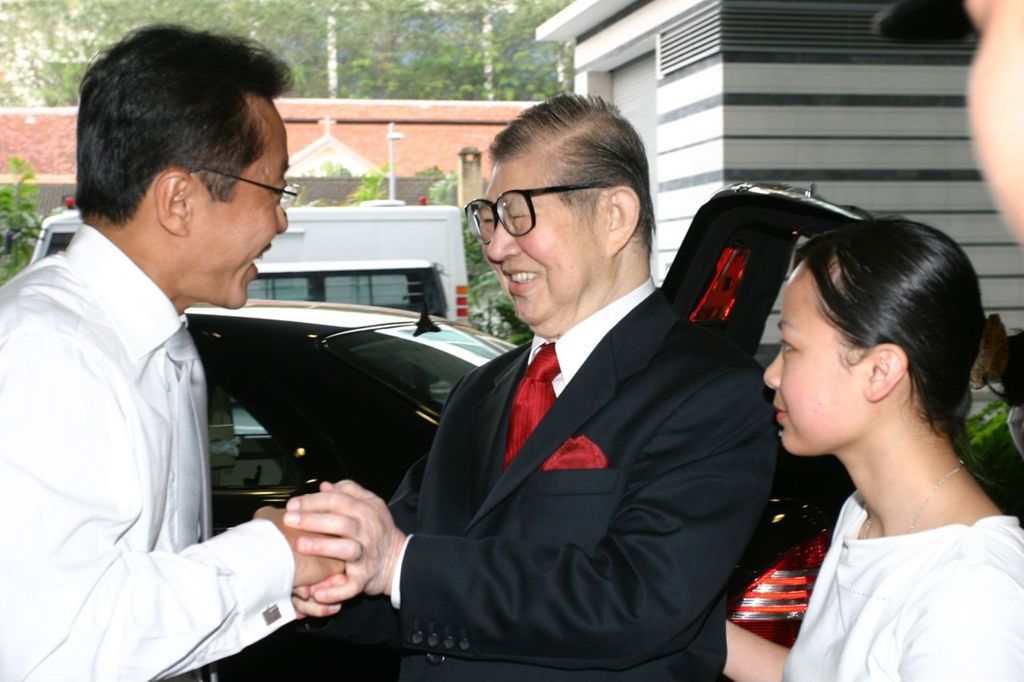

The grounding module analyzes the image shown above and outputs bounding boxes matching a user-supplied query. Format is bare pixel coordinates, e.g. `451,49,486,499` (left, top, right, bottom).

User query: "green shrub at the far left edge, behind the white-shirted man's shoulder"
0,158,42,284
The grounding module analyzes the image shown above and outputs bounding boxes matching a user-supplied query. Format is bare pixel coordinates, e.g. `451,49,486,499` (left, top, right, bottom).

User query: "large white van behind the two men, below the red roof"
33,205,469,322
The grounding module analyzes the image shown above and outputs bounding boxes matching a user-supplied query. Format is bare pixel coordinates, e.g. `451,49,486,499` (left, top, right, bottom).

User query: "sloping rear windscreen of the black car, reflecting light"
325,325,512,405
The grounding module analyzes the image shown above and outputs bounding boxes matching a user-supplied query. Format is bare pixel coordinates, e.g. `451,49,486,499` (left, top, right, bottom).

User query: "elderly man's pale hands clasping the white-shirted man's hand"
285,480,406,604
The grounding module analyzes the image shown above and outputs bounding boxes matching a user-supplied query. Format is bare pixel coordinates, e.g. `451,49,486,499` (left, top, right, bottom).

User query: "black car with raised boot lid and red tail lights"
188,185,866,680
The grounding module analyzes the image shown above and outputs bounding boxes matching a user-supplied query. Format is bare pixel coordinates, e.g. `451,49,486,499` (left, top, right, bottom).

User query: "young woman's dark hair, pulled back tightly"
797,218,985,440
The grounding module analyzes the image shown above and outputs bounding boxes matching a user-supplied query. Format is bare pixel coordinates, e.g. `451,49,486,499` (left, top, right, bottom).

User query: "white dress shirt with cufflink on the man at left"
0,226,294,682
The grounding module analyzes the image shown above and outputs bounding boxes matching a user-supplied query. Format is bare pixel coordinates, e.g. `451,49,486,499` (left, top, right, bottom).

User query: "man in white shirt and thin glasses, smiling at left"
0,27,342,681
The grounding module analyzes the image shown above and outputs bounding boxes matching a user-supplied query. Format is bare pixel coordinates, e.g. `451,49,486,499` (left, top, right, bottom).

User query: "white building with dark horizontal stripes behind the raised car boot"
539,0,1024,336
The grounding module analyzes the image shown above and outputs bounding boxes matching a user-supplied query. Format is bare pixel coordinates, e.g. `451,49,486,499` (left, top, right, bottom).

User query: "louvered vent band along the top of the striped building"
657,0,975,78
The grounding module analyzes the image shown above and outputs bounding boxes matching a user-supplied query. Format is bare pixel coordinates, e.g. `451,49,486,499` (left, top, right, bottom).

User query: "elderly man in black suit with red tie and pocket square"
285,95,776,681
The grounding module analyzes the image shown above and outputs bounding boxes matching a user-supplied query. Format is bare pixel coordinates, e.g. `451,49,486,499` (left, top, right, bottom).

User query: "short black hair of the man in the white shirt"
75,26,291,225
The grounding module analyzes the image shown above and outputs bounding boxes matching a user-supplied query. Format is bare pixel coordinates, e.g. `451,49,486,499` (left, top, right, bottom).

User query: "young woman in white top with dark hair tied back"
725,220,1024,682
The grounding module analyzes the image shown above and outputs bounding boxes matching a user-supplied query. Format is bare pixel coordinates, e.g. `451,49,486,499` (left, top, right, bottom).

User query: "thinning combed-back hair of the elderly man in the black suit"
490,94,654,253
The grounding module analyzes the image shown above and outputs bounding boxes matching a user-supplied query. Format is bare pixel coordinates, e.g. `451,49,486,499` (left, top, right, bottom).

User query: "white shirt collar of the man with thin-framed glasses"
66,225,184,360
